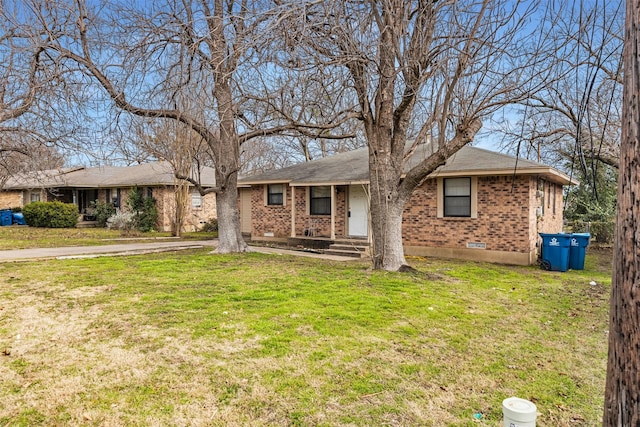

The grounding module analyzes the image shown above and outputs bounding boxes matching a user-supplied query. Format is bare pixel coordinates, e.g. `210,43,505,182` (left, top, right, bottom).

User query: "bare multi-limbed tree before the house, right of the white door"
287,0,544,270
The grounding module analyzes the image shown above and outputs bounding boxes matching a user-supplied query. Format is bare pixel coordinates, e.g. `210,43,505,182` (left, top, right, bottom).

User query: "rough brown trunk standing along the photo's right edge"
603,0,640,427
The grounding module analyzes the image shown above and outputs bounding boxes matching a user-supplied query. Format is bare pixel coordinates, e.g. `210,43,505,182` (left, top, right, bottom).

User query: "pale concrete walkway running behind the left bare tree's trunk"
0,240,358,263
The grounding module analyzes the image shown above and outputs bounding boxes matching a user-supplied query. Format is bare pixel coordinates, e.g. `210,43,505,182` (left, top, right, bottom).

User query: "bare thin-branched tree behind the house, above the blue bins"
501,0,624,172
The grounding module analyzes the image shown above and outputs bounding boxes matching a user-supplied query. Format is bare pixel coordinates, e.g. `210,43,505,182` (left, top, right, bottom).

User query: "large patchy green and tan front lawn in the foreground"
0,250,610,426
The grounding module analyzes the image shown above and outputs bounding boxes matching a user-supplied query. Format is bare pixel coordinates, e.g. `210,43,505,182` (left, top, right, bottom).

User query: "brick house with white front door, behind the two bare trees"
239,146,574,265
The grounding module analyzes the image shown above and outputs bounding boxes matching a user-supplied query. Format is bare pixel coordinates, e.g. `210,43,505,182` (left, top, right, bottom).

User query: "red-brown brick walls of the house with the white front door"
251,176,563,260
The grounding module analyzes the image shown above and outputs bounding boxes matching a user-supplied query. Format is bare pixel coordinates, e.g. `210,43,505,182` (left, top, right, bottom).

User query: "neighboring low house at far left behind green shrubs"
0,162,217,231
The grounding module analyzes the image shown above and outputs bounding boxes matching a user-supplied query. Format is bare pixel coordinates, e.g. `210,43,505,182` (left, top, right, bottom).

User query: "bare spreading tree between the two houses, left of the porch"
31,0,356,252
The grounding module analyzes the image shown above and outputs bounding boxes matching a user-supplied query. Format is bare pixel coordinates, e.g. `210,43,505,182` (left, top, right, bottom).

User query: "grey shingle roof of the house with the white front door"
239,146,575,185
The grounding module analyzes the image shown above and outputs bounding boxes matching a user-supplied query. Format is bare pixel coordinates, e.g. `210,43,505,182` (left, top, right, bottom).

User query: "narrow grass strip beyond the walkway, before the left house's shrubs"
0,226,217,250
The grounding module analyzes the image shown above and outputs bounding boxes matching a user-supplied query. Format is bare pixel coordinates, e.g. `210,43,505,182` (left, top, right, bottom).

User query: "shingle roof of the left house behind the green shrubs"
4,162,215,190
